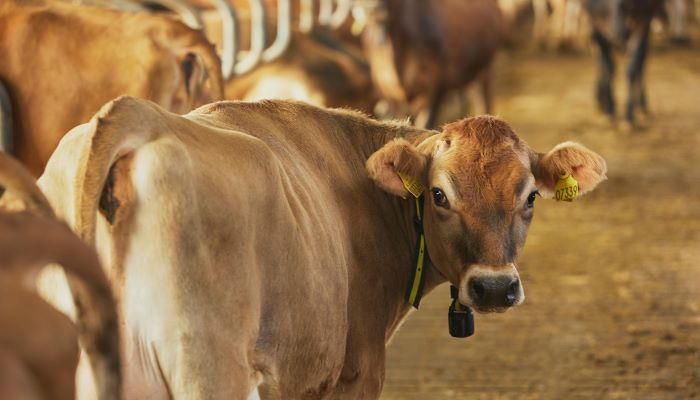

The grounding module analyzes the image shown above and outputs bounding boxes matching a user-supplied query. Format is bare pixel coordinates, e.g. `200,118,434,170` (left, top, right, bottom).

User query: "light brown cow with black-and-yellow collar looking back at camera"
40,97,606,399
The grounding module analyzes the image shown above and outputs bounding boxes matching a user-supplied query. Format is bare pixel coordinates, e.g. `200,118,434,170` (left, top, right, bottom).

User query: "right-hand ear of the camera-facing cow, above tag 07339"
530,142,608,197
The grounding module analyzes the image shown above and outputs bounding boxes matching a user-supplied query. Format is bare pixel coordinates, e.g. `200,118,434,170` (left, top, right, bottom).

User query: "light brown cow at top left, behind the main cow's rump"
0,0,223,176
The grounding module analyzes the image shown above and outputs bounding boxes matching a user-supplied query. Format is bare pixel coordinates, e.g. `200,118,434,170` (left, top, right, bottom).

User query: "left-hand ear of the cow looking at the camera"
366,139,427,198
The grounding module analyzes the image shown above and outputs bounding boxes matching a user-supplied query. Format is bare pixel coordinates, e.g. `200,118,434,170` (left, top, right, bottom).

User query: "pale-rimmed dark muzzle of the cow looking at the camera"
459,264,525,312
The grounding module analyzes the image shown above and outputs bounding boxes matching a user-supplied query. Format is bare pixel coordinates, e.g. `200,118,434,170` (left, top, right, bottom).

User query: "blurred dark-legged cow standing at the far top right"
584,0,664,125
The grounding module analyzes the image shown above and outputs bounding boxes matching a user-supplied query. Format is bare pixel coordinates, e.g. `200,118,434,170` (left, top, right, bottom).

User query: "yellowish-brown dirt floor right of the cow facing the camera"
382,33,700,400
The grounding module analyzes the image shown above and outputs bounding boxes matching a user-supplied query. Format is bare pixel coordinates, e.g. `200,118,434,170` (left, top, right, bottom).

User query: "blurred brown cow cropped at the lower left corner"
0,153,121,400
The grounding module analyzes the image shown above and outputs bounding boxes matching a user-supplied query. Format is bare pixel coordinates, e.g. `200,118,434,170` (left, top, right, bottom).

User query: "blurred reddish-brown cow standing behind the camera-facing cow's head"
358,0,504,127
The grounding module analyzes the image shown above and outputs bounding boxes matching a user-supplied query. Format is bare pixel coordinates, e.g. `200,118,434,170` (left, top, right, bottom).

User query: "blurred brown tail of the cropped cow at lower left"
0,213,121,400
